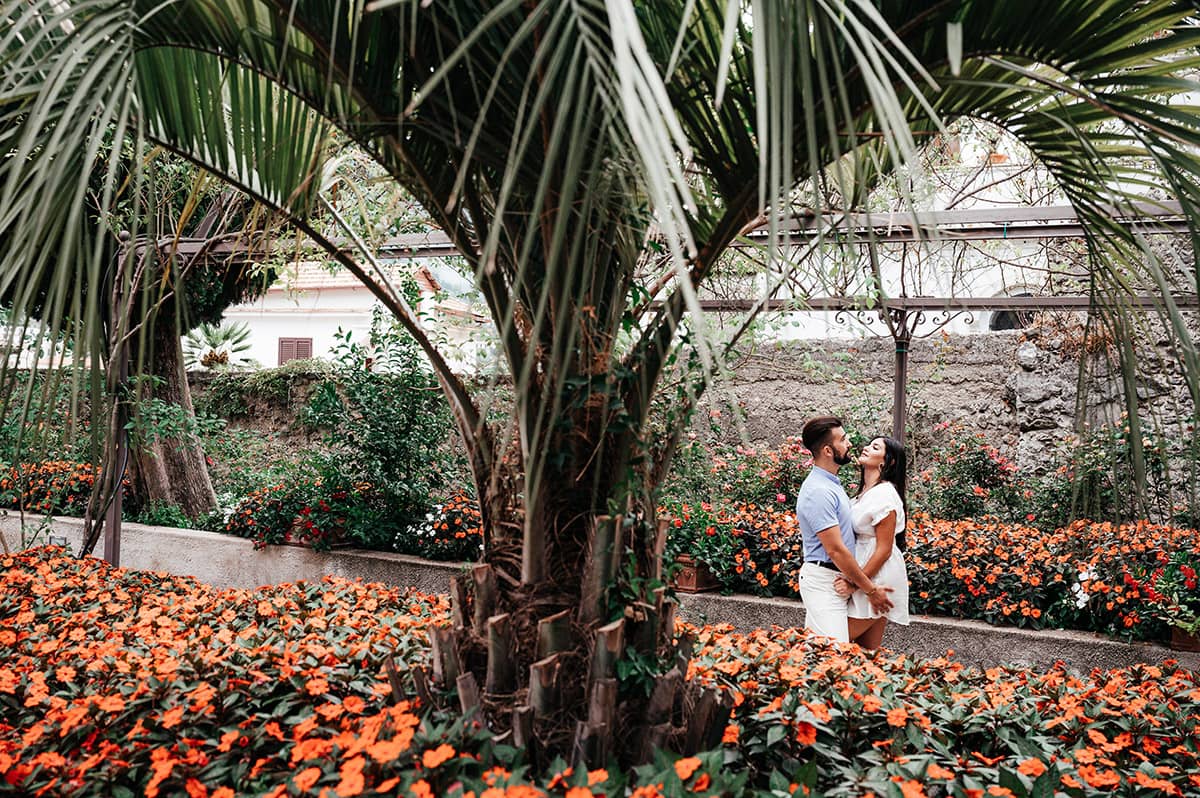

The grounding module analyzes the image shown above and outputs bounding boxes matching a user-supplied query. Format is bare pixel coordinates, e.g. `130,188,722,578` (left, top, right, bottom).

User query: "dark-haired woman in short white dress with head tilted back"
845,438,908,650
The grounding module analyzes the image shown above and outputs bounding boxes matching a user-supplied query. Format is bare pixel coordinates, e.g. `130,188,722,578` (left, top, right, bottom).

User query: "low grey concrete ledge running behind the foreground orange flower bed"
0,514,1200,671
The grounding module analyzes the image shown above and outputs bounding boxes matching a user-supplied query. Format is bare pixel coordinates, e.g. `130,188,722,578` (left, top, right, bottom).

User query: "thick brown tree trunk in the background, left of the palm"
130,319,217,520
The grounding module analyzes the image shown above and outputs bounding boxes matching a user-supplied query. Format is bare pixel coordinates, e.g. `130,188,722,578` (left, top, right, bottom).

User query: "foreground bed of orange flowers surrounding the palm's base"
0,548,1200,798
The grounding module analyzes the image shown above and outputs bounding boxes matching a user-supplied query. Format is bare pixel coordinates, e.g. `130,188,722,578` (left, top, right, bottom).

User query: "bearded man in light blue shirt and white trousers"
796,415,892,643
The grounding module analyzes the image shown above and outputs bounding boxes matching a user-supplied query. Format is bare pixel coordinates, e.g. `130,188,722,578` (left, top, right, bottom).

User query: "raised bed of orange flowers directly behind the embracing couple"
661,504,1200,640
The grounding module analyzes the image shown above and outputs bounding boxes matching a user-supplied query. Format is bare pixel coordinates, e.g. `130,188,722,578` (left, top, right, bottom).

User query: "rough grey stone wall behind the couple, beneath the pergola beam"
698,328,1192,470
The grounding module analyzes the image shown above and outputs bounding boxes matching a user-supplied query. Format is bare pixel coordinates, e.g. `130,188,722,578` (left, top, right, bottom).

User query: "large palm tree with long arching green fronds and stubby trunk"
7,0,1200,758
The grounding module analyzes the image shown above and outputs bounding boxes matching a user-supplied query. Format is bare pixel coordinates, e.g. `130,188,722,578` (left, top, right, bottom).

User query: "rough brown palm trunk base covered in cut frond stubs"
416,398,732,767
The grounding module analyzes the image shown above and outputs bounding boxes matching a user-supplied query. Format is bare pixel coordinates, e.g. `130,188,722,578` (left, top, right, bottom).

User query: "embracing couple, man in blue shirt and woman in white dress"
796,415,908,650
